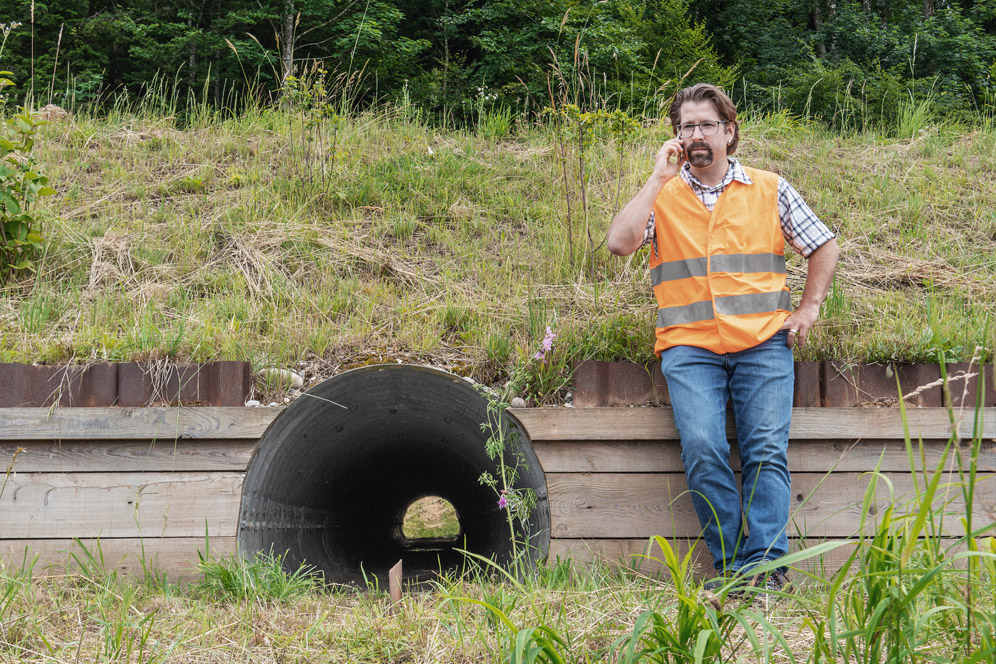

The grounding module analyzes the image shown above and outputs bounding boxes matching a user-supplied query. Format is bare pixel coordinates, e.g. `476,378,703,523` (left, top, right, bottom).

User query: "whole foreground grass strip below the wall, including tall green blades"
0,513,996,663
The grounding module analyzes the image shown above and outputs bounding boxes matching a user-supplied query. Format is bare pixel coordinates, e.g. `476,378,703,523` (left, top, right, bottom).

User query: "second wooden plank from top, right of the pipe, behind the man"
532,440,996,473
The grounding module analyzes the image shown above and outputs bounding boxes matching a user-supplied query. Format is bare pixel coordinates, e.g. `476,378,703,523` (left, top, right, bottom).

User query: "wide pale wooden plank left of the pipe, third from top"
0,472,243,539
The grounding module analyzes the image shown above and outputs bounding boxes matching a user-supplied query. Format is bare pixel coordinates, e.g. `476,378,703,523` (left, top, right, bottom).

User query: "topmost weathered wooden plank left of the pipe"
0,407,283,440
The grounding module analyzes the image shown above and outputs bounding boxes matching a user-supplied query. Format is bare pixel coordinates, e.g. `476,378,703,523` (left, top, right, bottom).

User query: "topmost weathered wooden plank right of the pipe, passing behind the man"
510,407,996,441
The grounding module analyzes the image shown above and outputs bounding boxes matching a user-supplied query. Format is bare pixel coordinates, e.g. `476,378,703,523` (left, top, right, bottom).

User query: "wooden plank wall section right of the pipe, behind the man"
516,408,996,567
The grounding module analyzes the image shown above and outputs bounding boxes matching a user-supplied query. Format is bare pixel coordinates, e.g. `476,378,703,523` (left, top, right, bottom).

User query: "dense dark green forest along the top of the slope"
0,0,996,126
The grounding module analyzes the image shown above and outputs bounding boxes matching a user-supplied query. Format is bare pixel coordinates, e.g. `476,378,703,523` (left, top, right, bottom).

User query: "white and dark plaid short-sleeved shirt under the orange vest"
641,157,836,258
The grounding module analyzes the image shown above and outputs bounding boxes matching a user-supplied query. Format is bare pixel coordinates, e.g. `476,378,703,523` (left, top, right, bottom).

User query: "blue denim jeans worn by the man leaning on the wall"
661,331,795,573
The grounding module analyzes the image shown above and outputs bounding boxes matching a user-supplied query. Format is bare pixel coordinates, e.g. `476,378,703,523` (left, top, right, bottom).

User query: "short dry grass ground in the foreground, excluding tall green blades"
0,548,992,664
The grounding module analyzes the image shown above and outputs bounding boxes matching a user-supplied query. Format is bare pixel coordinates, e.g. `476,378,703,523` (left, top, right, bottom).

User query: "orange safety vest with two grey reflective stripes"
650,168,792,356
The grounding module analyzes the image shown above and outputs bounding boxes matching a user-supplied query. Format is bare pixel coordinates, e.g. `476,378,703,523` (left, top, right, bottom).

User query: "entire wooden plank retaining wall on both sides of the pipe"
0,407,996,578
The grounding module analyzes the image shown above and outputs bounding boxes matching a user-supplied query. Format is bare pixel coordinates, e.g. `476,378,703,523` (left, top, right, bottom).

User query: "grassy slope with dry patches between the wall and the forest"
0,106,996,392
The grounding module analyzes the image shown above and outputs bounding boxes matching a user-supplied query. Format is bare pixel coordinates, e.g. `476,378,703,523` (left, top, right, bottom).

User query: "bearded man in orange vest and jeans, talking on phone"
607,83,839,591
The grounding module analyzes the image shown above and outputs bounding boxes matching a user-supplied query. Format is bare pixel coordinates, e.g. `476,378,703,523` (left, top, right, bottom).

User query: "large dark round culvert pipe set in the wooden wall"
238,364,550,583
